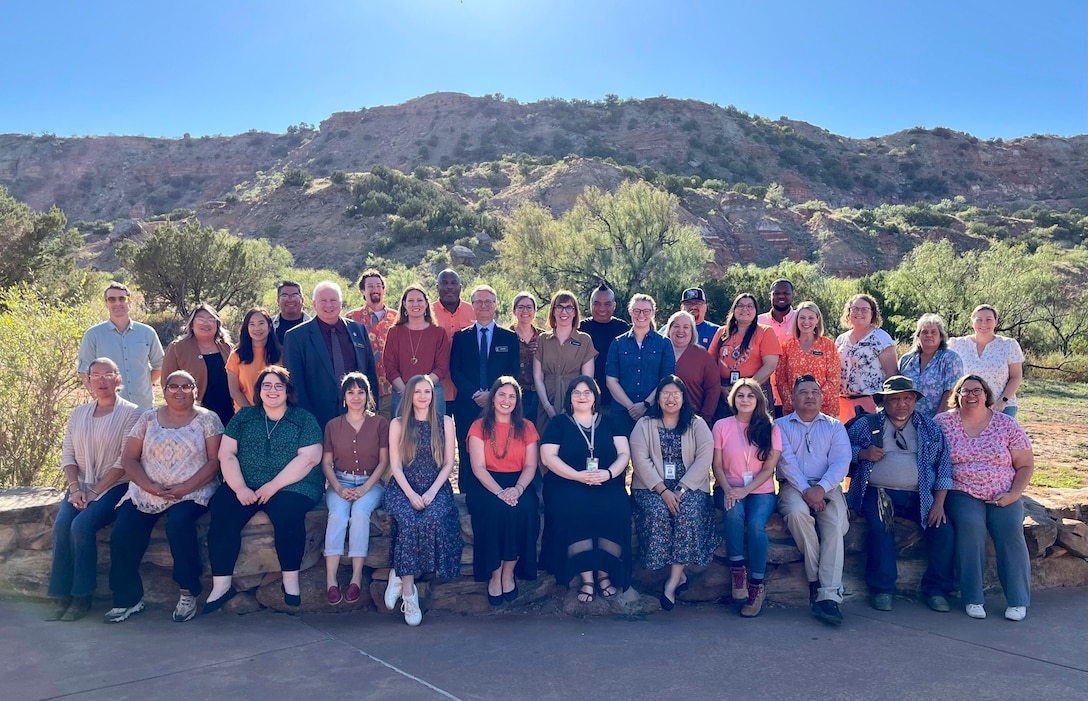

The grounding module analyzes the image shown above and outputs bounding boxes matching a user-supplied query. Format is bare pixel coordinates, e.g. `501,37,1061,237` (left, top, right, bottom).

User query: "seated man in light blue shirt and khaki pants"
775,374,851,626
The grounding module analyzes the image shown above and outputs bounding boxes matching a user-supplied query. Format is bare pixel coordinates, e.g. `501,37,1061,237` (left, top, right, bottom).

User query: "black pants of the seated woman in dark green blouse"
208,482,316,577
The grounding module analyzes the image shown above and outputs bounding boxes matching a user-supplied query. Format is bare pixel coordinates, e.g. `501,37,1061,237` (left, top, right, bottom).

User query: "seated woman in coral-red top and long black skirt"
469,376,540,606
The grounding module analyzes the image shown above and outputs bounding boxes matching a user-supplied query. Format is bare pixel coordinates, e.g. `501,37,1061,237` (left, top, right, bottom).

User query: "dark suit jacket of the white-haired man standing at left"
283,317,381,428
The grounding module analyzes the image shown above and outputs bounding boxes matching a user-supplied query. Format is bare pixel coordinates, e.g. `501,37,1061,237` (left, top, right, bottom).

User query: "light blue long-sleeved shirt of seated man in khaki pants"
775,411,853,492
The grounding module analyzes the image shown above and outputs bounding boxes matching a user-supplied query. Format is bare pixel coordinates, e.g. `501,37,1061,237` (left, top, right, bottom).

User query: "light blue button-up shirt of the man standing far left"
78,320,163,411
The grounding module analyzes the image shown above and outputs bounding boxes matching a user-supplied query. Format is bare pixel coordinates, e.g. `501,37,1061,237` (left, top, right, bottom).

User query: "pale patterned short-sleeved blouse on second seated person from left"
121,406,223,514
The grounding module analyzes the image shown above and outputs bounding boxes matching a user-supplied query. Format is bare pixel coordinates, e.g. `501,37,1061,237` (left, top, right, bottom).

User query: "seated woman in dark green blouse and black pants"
202,365,325,614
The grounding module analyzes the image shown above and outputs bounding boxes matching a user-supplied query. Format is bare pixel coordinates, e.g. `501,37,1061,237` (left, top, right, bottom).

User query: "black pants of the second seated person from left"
110,501,208,608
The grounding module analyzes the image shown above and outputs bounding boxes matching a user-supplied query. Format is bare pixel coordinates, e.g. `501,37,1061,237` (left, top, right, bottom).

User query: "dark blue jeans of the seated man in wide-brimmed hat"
862,487,955,597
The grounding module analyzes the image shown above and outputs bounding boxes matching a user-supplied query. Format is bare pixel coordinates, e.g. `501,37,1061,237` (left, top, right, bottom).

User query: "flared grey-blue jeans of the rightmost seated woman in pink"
944,491,1031,606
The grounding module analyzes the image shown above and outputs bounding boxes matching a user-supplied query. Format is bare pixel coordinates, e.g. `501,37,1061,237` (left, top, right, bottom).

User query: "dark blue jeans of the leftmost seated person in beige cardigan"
48,482,128,599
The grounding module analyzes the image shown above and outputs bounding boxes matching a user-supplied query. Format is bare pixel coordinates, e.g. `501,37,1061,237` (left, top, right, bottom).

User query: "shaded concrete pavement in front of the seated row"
0,588,1088,701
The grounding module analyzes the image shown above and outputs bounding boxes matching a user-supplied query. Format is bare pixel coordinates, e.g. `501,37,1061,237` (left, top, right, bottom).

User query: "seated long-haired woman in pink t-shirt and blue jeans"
714,378,782,618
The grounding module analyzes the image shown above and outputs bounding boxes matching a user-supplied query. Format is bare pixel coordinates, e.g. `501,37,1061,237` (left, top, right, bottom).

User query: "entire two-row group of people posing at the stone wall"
49,270,1033,625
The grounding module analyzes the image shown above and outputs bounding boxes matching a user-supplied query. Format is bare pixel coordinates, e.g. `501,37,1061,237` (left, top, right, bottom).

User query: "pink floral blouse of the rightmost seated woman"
934,409,1031,501
